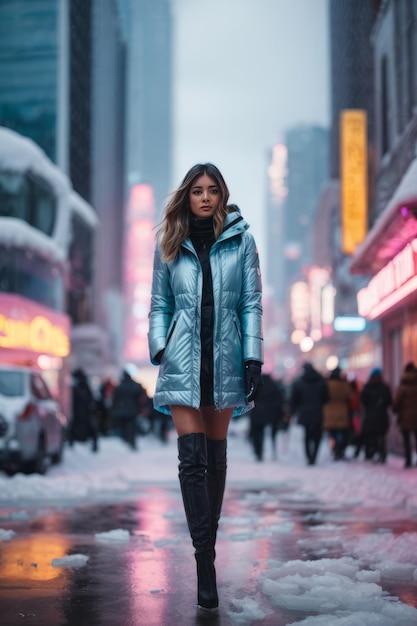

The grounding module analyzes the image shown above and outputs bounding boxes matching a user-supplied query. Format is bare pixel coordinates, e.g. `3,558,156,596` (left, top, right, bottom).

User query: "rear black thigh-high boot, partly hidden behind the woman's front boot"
206,439,227,556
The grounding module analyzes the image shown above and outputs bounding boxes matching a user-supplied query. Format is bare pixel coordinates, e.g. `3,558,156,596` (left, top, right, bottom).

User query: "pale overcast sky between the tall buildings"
172,0,330,264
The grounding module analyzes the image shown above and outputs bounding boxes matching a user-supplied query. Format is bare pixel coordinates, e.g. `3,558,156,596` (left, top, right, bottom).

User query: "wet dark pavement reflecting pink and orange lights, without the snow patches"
0,472,417,626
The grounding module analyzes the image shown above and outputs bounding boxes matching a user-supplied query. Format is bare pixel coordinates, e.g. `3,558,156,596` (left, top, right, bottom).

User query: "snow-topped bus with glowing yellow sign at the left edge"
0,127,97,410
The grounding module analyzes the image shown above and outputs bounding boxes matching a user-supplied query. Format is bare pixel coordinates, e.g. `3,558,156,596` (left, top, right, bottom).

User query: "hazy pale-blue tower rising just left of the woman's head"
120,0,172,216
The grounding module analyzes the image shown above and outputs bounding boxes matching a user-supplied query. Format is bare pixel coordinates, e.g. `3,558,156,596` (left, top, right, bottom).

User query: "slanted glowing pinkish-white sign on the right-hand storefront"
357,239,417,319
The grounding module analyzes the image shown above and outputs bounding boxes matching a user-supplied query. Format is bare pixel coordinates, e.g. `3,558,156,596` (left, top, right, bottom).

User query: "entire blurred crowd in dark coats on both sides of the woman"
68,362,417,468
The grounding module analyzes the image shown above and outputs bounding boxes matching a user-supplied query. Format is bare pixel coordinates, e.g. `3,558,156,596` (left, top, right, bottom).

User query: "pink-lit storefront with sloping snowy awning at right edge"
351,159,417,388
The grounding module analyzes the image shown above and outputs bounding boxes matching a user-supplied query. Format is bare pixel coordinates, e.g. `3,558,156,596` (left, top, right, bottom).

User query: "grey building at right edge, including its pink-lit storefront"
351,0,417,387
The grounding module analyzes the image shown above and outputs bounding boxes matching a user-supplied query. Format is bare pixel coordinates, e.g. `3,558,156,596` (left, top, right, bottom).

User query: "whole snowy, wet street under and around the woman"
0,419,417,626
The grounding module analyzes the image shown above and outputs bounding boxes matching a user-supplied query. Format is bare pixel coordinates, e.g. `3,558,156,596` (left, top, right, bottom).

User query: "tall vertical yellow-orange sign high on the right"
340,109,368,254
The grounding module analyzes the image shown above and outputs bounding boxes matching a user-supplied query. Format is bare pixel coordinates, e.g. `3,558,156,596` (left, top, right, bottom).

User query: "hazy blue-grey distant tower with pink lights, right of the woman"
266,124,329,376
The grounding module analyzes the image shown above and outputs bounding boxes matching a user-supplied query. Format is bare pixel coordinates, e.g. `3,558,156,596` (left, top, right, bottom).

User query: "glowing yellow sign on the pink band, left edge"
0,314,70,357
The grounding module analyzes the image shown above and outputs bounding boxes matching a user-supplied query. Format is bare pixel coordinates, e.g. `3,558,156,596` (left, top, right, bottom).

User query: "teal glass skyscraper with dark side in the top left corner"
0,0,92,201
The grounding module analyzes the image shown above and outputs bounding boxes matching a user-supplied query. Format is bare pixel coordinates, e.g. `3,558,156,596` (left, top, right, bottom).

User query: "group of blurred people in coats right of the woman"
249,362,417,468
